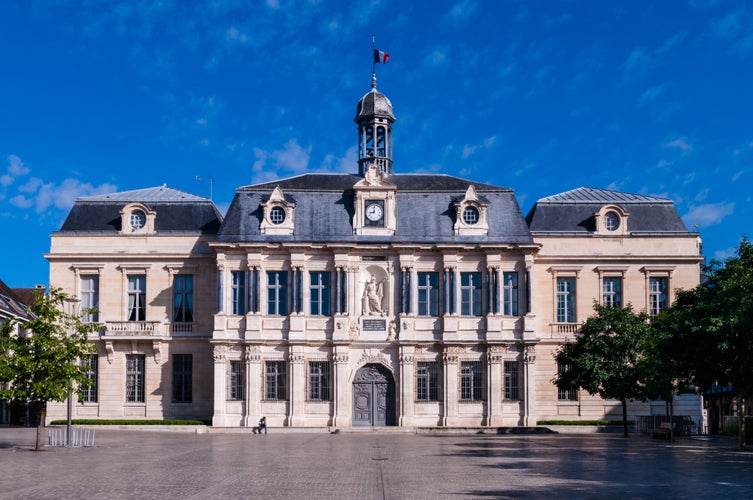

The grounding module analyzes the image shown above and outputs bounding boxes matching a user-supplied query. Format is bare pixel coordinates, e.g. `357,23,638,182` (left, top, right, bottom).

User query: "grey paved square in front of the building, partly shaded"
0,428,753,499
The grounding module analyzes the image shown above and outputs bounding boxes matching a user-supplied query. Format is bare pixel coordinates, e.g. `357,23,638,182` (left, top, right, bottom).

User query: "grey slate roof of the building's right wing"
526,187,688,234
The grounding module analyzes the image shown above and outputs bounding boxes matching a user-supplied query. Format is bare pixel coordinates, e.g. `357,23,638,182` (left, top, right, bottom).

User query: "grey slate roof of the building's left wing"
59,186,222,234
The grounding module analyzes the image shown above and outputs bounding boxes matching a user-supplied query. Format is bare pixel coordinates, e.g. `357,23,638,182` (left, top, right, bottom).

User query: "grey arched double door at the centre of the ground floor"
353,364,395,426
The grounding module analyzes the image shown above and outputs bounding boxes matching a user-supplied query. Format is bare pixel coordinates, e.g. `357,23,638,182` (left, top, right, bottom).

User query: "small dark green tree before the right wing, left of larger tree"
554,303,650,437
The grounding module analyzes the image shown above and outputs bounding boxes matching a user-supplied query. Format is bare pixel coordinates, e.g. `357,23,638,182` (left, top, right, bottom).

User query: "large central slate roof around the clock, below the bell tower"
219,174,533,244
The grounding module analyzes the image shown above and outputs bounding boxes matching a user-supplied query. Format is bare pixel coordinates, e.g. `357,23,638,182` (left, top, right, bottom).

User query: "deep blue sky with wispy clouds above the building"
0,0,753,287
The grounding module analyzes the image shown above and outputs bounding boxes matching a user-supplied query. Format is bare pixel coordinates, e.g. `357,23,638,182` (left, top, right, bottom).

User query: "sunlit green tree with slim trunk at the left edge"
0,288,97,450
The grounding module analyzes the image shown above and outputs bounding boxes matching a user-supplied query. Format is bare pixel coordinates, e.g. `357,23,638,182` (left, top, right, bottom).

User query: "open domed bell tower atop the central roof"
353,72,395,177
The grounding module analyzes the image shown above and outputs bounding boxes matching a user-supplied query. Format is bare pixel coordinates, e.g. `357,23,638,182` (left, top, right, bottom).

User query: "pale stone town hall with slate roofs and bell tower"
46,77,702,428
